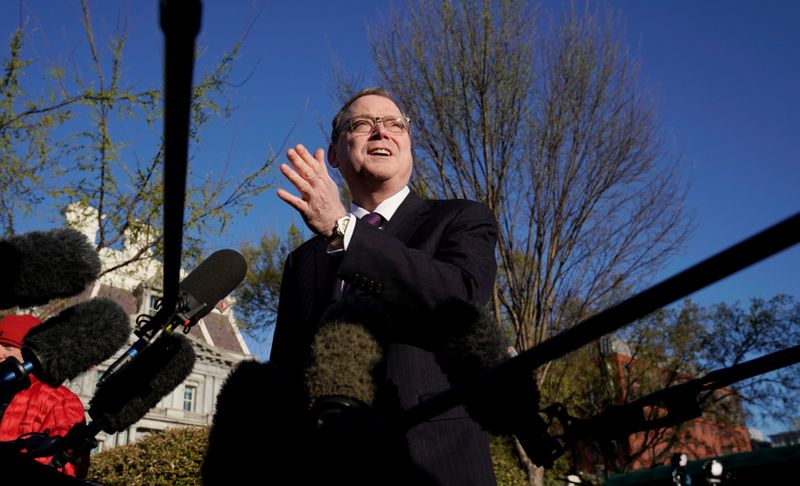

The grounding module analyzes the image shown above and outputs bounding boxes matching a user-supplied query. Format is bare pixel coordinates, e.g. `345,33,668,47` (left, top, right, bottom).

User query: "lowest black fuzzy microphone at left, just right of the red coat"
49,334,195,467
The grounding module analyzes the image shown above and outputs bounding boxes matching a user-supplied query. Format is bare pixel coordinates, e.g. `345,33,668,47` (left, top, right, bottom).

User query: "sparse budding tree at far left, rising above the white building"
0,0,275,273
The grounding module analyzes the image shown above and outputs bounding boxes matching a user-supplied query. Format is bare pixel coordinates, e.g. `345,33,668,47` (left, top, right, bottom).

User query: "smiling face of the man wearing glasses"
328,95,413,195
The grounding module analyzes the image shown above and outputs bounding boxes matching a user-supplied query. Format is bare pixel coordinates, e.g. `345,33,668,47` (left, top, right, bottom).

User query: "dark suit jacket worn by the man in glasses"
270,193,497,485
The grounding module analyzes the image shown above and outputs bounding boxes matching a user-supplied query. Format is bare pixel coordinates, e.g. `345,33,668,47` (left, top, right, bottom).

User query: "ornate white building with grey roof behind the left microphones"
65,205,253,451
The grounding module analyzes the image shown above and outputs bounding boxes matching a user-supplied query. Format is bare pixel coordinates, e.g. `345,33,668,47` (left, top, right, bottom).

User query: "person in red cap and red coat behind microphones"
0,315,89,478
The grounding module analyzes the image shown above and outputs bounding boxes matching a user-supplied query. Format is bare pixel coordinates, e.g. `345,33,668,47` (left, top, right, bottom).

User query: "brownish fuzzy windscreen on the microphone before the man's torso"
305,296,388,409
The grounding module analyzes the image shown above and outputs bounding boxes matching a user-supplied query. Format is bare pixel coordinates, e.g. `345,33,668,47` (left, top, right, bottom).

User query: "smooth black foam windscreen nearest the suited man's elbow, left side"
180,249,247,319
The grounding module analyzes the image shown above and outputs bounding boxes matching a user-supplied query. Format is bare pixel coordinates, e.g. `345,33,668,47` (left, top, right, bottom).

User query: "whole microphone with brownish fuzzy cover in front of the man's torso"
301,294,412,484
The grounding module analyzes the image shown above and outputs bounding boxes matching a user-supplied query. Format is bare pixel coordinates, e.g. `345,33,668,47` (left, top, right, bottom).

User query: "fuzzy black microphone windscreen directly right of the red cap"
22,298,131,386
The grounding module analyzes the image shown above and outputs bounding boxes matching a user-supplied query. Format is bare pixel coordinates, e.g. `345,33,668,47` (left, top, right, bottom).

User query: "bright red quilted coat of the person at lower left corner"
0,375,89,478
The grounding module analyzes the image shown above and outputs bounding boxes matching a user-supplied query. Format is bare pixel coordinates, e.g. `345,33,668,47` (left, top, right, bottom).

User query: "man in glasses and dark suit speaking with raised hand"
270,88,497,485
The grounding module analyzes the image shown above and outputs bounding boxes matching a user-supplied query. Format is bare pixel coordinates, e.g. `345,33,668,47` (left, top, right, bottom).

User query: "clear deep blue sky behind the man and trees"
6,0,800,406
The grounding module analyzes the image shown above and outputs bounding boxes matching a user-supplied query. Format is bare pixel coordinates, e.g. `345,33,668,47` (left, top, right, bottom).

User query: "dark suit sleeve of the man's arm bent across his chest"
338,201,497,312
